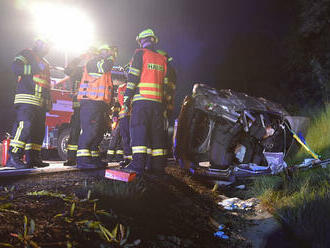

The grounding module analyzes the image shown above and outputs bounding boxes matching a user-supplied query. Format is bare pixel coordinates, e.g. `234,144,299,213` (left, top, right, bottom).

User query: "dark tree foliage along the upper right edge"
286,0,330,113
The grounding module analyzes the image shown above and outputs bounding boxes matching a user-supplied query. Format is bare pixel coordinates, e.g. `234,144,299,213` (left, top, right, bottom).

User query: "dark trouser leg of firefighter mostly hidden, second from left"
67,107,80,161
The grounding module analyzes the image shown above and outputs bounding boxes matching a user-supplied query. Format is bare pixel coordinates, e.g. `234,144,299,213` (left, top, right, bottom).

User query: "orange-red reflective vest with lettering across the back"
133,49,167,103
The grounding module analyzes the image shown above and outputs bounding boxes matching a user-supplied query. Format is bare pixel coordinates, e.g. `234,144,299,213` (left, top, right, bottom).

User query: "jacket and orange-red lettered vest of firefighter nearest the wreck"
125,48,167,103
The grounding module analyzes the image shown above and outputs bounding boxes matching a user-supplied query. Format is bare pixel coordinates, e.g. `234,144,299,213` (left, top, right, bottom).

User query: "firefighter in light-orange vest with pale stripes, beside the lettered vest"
77,45,117,168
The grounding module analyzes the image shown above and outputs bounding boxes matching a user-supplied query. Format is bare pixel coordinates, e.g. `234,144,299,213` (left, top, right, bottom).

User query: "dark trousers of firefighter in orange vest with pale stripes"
77,101,107,163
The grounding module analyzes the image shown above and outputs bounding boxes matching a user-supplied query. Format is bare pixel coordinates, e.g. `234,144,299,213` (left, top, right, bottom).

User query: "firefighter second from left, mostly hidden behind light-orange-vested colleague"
64,47,97,166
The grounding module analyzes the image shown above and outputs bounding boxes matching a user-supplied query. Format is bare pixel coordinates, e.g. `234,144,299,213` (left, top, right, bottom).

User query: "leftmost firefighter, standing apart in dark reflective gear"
7,38,51,169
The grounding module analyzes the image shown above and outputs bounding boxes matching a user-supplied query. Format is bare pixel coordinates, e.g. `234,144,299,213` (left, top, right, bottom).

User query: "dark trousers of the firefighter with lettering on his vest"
130,100,165,173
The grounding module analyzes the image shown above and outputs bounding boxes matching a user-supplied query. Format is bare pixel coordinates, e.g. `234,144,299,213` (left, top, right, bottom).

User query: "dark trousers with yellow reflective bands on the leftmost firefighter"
9,103,46,163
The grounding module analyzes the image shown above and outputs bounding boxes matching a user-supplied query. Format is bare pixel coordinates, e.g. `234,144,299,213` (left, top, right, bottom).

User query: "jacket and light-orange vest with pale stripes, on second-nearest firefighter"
78,56,113,104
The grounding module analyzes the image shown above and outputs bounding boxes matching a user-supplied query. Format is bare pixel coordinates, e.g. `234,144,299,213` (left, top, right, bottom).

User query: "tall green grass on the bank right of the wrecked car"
251,105,330,247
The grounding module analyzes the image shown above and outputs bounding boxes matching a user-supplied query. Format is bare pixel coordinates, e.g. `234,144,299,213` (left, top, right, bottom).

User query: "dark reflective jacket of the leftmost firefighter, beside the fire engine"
12,49,51,107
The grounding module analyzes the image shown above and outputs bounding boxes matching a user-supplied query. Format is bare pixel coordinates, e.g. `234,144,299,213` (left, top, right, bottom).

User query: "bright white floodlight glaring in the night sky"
30,2,94,53
